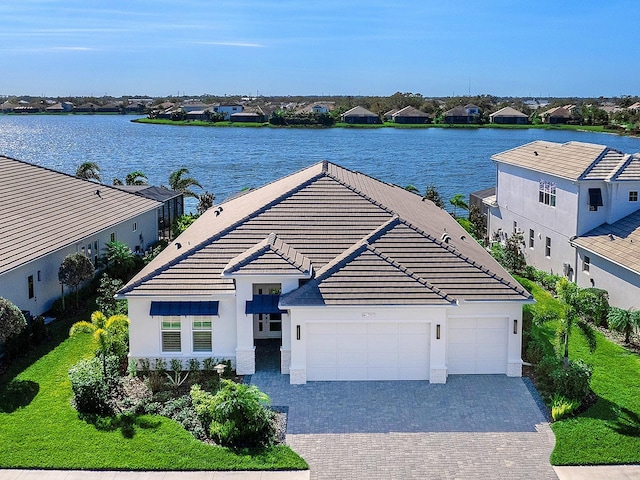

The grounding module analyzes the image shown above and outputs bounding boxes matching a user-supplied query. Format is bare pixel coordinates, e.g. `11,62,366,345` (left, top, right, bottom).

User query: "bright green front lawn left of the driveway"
0,335,308,470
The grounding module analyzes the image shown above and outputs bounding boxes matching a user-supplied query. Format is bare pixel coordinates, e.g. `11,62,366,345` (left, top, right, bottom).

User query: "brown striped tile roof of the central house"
121,162,530,305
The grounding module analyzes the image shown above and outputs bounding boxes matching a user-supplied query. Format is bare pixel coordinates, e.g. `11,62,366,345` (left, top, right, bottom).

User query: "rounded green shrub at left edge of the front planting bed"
69,357,119,415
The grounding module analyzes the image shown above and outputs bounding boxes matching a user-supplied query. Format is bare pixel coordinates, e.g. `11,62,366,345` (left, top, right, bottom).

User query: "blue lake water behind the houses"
0,115,640,209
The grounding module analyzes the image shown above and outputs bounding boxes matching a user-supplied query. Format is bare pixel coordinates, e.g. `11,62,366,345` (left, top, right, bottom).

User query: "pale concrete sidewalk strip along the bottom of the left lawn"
0,470,310,480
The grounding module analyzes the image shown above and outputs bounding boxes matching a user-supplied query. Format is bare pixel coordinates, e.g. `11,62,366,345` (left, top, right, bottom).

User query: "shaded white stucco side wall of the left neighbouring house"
0,209,158,315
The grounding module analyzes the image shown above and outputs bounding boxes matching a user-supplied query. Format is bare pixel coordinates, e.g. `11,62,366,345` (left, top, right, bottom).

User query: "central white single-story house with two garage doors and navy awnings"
119,161,532,384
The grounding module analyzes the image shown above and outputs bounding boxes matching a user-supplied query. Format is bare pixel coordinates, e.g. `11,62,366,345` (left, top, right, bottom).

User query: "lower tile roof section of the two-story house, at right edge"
571,210,640,274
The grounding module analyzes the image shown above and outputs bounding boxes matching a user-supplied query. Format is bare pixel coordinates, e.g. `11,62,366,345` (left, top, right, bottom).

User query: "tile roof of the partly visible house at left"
0,156,160,274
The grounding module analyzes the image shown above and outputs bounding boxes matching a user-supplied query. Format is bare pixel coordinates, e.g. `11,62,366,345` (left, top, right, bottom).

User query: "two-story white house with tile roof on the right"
485,141,640,308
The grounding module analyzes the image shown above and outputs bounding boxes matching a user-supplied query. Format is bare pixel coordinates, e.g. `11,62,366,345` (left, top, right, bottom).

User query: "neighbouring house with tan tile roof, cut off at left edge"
0,156,161,315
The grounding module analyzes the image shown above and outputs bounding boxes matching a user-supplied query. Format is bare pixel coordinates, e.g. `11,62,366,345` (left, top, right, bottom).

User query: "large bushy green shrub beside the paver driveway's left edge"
191,380,275,448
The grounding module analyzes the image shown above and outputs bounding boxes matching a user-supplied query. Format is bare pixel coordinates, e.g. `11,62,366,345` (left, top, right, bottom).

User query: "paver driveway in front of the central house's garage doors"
249,344,557,480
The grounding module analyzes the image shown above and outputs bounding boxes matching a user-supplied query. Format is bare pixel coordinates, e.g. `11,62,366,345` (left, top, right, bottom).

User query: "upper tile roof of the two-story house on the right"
491,140,640,180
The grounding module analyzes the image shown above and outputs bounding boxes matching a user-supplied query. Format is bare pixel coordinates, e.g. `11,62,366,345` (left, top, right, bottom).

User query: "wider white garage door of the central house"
306,323,430,380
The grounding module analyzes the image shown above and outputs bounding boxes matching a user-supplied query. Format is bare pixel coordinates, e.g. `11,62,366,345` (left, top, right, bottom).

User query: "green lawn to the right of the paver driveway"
519,279,640,465
